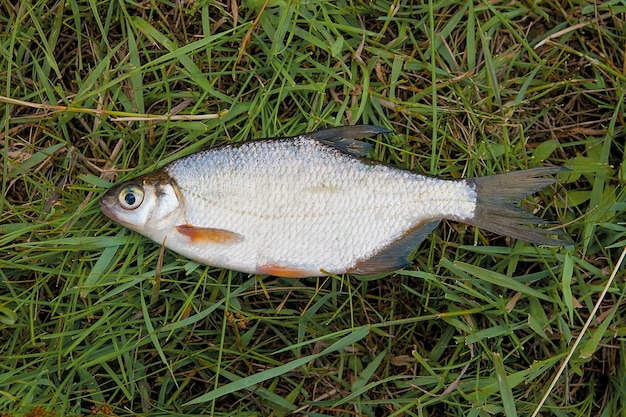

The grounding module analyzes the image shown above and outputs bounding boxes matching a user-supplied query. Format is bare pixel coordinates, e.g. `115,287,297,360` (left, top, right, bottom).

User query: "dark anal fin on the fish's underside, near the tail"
347,220,439,274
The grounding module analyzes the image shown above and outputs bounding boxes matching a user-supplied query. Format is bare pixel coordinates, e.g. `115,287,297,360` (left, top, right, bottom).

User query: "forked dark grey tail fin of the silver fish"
464,167,572,246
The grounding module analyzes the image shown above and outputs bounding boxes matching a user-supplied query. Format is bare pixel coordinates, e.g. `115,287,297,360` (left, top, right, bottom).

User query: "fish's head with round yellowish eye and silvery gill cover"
100,174,184,237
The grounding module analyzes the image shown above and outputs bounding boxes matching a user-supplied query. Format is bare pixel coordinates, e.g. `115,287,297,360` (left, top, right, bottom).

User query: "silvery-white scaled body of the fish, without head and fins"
166,136,476,276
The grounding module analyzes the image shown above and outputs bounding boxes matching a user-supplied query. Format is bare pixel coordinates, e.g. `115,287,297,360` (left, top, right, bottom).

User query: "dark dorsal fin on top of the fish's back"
308,125,391,156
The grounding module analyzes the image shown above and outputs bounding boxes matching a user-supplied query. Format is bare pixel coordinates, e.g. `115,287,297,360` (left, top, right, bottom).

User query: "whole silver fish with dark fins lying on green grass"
100,125,569,278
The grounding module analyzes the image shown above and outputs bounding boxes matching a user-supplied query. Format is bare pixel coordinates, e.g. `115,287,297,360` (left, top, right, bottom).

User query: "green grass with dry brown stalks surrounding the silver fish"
0,0,626,417
